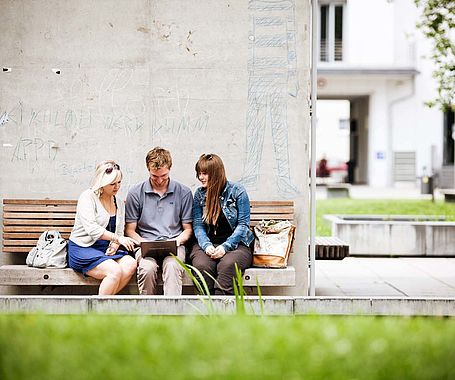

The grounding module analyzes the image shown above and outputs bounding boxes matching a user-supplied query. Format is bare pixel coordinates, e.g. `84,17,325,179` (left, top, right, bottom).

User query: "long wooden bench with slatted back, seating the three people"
0,199,295,287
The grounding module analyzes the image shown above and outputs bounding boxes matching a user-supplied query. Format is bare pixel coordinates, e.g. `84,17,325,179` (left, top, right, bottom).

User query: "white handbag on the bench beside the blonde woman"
25,230,67,268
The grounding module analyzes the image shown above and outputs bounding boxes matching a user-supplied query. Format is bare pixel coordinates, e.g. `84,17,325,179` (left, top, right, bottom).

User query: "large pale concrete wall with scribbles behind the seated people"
0,0,310,294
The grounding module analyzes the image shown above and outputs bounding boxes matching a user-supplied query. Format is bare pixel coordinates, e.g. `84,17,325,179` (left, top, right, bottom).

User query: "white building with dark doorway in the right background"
317,0,454,187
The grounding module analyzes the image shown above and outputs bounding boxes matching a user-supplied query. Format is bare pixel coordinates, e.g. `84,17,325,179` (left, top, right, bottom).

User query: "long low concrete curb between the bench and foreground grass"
0,296,455,316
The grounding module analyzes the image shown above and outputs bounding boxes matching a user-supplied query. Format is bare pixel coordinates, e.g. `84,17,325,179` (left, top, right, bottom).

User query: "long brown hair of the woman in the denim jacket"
195,154,227,225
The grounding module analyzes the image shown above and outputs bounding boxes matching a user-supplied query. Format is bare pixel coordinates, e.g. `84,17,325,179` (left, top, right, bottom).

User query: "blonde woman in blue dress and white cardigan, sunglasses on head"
68,161,137,295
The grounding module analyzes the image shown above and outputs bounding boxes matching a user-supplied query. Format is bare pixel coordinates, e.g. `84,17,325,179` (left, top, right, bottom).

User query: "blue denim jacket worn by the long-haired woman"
193,181,254,252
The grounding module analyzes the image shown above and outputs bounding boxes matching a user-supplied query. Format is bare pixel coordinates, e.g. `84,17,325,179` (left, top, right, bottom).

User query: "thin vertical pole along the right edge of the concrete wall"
309,0,318,297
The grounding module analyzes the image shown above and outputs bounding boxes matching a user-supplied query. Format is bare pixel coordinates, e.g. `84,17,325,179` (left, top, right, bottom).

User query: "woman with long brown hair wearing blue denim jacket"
190,154,254,294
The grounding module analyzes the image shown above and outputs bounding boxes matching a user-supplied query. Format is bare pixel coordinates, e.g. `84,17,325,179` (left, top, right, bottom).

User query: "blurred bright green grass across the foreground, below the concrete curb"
0,314,455,380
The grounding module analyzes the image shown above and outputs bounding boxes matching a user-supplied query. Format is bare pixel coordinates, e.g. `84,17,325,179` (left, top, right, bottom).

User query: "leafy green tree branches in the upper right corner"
414,0,455,111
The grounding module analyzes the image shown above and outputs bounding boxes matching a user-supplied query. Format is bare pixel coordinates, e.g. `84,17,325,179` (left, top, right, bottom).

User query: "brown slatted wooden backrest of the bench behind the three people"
3,199,294,253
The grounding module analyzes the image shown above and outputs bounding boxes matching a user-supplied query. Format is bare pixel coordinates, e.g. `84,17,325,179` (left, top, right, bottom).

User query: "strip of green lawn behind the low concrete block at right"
316,198,455,236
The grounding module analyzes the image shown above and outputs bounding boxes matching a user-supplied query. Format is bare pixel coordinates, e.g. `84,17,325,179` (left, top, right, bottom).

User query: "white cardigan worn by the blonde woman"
70,189,125,247
